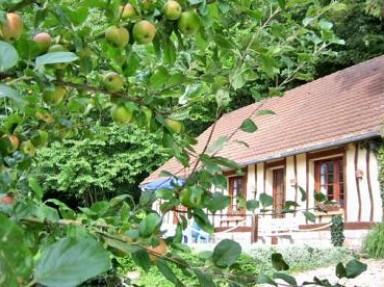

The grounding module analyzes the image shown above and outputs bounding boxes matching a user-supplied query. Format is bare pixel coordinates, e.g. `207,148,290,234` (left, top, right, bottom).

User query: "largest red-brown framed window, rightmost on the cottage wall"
315,157,345,207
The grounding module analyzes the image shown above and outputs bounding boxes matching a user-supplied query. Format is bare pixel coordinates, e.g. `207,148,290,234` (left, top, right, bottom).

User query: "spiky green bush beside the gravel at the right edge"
363,222,384,258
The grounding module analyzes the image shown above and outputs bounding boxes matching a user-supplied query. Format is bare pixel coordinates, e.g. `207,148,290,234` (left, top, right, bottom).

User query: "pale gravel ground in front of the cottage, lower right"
294,259,384,287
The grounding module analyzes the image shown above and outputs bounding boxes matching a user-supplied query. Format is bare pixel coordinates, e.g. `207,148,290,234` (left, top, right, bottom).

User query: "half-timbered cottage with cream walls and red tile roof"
142,56,384,248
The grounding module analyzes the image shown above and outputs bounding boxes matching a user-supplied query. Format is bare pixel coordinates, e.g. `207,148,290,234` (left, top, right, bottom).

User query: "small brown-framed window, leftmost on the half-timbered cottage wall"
228,176,246,214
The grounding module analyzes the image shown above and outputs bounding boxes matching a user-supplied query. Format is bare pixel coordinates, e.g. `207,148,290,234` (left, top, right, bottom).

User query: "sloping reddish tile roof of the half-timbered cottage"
142,56,384,184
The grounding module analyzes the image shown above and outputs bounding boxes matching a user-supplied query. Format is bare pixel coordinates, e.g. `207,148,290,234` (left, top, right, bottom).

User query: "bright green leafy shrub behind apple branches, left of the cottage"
34,125,166,206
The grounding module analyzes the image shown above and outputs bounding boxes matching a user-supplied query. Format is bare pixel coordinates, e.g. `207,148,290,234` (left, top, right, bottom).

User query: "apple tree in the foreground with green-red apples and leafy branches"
0,0,363,286
